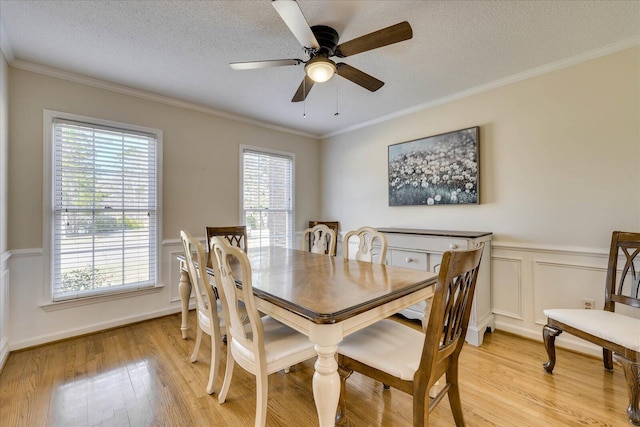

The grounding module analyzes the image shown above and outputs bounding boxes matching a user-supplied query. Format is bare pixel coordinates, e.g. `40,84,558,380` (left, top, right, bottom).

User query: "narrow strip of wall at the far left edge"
0,51,9,369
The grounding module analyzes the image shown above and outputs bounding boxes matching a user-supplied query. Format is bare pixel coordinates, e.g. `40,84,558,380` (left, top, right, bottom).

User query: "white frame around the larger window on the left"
40,109,163,311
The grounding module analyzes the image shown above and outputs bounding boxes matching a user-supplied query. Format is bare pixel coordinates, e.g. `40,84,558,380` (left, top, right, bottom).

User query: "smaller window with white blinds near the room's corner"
240,146,294,248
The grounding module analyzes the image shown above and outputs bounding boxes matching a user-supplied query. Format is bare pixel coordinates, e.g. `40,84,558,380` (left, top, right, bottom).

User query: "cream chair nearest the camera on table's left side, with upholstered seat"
209,237,317,427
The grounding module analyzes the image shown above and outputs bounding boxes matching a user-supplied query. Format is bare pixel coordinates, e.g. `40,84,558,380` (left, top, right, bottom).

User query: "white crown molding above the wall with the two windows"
7,58,319,139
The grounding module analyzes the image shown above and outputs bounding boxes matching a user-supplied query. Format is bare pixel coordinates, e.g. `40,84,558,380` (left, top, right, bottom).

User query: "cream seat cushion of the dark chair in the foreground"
338,319,424,380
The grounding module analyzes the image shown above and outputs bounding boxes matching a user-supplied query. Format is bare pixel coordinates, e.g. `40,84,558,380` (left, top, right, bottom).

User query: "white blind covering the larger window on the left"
52,119,158,301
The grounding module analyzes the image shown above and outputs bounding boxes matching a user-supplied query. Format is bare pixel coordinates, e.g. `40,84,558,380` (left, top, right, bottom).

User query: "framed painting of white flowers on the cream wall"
389,126,480,206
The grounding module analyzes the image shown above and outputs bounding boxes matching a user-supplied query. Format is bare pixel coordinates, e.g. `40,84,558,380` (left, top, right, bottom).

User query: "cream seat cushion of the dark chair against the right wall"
544,308,640,351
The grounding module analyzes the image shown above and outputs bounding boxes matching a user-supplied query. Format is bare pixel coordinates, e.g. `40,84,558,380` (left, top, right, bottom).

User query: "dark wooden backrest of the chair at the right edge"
604,231,640,311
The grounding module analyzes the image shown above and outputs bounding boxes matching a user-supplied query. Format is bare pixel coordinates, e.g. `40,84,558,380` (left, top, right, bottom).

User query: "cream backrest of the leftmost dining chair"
180,231,220,327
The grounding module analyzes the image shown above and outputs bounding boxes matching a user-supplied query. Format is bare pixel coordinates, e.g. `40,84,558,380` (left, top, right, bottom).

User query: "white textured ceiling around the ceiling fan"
0,0,640,136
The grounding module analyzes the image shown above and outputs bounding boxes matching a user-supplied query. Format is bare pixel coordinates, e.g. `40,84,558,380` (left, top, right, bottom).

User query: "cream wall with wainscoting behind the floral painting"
322,47,640,354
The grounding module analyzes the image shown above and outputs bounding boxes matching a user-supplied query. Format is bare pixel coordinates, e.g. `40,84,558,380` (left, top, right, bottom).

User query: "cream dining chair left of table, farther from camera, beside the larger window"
180,231,225,394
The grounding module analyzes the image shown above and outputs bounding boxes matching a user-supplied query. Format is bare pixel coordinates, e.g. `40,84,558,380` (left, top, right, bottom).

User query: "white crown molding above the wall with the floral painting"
320,37,640,139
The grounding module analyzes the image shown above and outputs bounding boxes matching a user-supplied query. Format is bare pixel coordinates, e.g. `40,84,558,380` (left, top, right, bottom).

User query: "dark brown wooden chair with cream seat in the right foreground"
336,244,484,427
